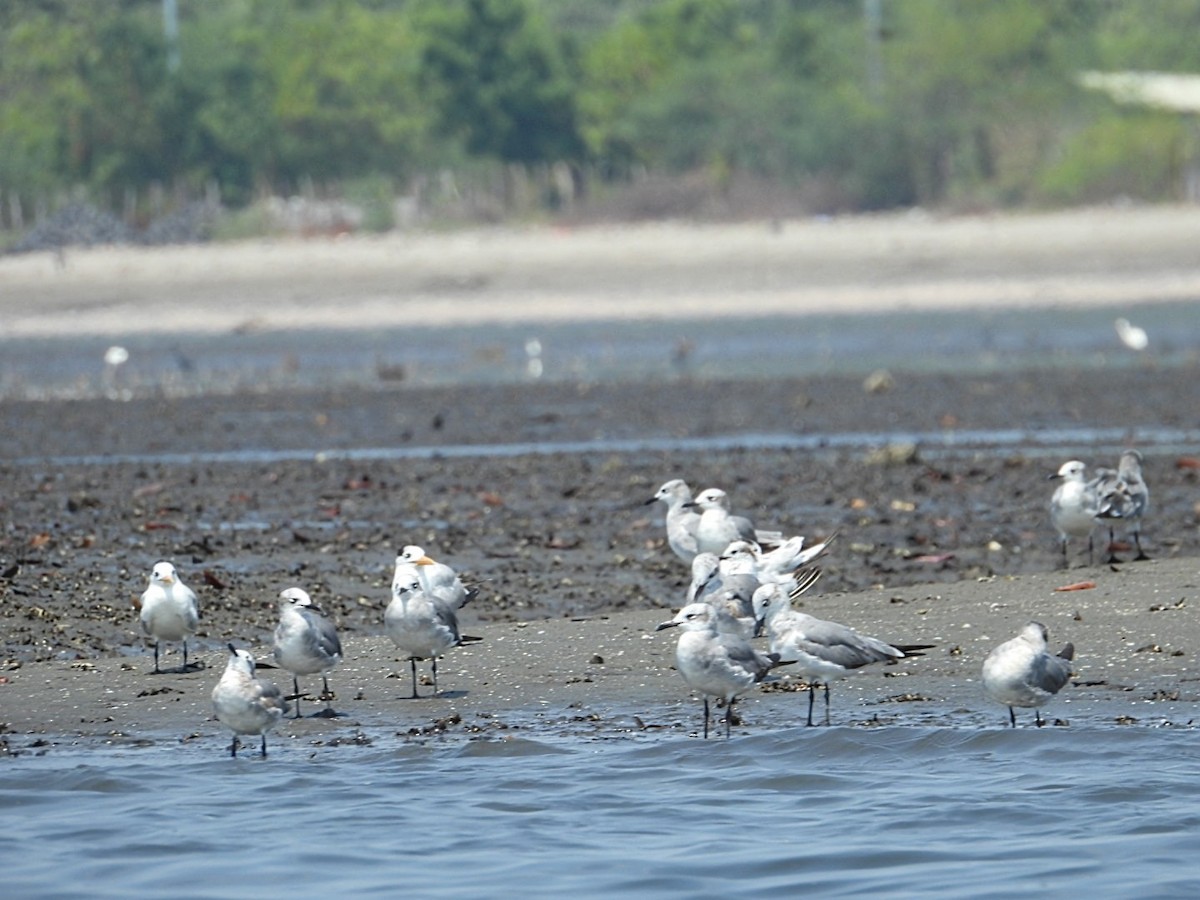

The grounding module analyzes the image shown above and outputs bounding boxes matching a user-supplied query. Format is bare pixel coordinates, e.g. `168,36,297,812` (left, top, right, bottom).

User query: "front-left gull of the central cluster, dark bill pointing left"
655,604,780,738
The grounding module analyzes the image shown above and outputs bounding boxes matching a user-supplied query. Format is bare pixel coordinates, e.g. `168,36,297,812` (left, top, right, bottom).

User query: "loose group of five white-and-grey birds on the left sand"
134,545,480,756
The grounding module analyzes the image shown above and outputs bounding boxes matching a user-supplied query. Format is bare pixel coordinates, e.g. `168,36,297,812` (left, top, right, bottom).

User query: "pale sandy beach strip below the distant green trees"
7,205,1200,340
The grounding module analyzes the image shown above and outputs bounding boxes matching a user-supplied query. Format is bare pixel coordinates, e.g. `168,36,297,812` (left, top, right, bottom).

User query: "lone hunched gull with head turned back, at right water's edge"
983,622,1075,728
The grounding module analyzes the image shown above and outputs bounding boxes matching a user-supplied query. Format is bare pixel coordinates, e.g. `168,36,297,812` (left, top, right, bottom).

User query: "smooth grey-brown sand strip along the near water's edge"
0,559,1200,755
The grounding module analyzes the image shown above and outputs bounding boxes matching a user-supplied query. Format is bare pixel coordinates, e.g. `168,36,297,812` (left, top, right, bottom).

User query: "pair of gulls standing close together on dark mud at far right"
1049,450,1150,569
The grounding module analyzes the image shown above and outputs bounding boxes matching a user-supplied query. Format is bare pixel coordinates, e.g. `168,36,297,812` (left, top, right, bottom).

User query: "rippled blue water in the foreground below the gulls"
0,727,1200,898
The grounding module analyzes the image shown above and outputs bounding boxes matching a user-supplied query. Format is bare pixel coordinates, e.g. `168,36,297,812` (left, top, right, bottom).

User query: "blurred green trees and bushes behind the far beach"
0,0,1200,229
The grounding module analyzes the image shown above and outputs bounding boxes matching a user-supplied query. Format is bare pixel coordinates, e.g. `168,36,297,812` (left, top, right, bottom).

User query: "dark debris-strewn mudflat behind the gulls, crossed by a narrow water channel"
0,367,1200,665
